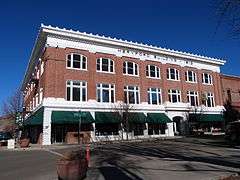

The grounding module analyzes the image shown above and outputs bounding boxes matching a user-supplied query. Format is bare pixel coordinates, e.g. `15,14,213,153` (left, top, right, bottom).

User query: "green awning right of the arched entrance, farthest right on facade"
189,114,224,122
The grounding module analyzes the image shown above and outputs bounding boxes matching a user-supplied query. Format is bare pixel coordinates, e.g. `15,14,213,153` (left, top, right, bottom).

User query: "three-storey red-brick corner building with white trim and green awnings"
22,25,225,145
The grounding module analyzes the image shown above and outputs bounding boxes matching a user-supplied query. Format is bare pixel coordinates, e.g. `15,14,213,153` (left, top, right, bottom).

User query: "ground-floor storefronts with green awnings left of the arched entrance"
24,108,173,144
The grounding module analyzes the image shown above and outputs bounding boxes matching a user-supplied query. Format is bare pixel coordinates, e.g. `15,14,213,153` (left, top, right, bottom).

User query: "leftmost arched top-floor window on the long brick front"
67,53,87,70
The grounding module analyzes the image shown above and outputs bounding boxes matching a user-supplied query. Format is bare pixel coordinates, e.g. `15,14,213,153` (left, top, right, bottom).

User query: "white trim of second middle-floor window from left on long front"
96,83,116,103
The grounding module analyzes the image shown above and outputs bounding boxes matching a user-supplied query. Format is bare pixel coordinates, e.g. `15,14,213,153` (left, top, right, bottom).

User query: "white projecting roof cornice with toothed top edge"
21,24,226,91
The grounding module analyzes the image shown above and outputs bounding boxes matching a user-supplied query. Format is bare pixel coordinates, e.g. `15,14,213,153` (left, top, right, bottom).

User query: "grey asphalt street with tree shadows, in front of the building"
0,138,240,180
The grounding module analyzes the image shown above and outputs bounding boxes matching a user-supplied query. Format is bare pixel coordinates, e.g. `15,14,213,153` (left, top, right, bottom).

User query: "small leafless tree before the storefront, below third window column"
114,102,133,140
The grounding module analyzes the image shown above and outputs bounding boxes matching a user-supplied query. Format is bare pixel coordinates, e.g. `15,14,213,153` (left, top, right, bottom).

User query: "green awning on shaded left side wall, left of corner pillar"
24,108,44,126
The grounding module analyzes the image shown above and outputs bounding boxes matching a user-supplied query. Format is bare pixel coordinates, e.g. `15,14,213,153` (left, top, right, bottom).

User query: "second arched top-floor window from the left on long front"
97,58,114,73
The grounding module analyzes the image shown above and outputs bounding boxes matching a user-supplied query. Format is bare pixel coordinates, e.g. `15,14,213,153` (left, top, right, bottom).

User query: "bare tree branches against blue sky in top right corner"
215,0,240,37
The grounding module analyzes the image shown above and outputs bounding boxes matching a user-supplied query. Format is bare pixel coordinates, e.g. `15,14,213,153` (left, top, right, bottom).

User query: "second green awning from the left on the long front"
95,112,121,124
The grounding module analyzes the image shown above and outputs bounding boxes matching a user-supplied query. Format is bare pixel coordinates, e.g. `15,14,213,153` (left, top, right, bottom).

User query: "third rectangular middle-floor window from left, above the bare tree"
124,86,140,104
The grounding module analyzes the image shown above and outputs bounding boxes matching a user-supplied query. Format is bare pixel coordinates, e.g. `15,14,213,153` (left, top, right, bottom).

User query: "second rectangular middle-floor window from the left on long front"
97,84,115,103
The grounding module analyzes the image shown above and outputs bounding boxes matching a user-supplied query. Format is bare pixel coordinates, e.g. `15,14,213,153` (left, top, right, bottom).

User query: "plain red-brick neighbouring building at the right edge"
220,74,240,111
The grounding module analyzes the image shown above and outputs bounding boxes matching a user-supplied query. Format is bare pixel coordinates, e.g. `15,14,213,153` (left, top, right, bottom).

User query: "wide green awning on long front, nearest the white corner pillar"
51,111,94,124
